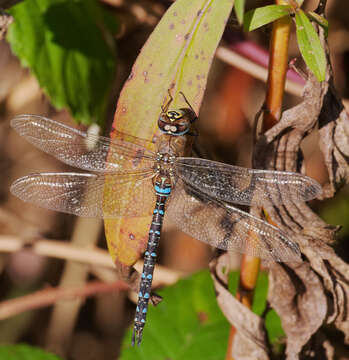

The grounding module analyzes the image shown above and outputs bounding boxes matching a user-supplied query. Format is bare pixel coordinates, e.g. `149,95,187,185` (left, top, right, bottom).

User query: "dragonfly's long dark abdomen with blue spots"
132,175,172,345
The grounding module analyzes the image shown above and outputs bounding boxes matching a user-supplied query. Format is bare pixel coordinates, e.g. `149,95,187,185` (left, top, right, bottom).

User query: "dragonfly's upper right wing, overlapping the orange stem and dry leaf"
176,157,322,205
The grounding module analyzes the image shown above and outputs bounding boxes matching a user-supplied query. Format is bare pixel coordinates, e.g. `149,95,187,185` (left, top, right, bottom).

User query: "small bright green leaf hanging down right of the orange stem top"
295,10,326,81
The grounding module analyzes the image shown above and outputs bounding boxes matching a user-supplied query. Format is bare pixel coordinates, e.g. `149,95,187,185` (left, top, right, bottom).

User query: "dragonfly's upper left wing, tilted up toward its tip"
11,115,154,172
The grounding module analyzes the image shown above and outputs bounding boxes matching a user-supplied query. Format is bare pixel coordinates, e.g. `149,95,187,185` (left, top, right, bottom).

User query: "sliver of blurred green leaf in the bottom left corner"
0,344,61,360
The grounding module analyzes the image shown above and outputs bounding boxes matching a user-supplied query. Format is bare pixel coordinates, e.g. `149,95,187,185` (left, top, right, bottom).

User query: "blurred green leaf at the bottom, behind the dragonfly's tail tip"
120,271,230,360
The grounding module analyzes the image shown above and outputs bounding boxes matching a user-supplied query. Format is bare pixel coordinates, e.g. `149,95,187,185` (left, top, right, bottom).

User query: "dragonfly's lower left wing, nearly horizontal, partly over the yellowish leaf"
10,173,155,218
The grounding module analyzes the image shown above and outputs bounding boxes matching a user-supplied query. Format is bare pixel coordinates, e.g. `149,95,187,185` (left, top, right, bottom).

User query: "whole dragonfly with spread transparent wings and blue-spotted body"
10,94,321,345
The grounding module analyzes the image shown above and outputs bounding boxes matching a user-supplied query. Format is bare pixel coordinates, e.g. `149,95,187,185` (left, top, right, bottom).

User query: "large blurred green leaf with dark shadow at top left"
7,0,117,124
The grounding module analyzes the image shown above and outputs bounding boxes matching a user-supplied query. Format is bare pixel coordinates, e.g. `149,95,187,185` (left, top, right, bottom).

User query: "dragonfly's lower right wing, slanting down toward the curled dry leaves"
165,181,301,262
